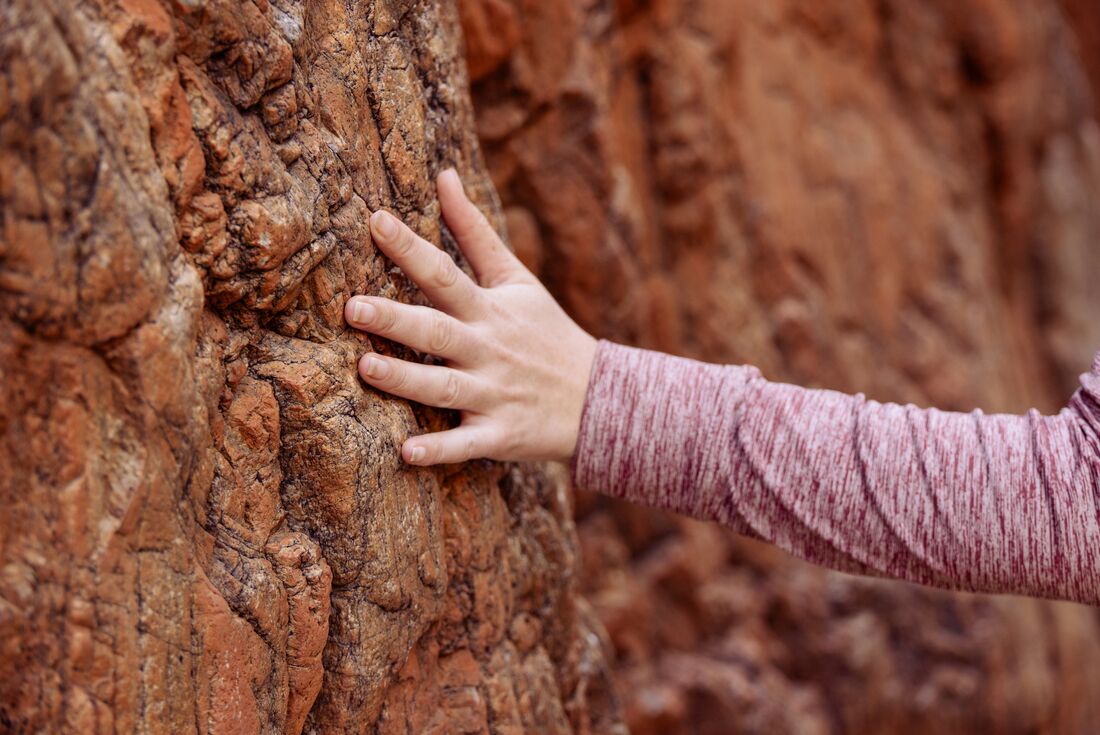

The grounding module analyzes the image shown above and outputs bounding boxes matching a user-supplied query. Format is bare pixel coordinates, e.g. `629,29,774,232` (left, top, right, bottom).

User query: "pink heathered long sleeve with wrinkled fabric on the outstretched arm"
572,342,1100,604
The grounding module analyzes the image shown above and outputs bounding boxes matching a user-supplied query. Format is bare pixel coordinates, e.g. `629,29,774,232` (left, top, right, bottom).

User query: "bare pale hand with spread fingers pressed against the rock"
344,169,596,465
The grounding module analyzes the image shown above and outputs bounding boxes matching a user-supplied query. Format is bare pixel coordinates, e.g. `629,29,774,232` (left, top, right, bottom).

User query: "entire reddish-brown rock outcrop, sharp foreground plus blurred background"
0,0,1100,735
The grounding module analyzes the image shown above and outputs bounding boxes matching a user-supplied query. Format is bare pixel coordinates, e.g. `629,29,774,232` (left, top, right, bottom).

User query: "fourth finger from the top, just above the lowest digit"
359,352,484,409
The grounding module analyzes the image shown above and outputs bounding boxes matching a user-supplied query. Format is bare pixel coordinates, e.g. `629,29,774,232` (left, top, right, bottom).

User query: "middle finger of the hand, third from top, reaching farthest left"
344,296,476,363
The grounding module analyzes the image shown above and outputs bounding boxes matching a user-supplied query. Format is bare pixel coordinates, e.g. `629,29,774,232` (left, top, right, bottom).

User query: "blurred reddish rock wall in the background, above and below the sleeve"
462,0,1100,735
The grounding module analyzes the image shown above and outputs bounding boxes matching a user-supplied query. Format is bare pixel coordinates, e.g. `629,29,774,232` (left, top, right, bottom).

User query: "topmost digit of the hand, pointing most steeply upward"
437,168,527,288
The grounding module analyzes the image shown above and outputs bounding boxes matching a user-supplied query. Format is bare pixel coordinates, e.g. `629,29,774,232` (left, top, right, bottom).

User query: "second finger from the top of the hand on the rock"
371,210,481,319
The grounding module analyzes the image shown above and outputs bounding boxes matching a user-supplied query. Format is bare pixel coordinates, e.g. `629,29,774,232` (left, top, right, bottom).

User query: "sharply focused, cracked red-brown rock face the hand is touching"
0,0,618,734
